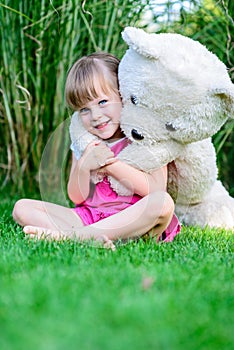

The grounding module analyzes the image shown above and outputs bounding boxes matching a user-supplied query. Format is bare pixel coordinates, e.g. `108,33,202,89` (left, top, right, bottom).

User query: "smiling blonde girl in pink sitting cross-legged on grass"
13,53,180,249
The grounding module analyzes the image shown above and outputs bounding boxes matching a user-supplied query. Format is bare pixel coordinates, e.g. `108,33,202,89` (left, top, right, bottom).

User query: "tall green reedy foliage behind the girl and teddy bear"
0,0,234,195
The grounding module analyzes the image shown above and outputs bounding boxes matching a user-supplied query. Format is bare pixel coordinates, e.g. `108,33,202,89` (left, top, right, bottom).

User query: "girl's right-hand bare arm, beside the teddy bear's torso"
105,160,167,197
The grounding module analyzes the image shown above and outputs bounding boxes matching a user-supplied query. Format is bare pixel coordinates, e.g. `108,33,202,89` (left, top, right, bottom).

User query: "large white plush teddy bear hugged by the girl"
70,27,234,229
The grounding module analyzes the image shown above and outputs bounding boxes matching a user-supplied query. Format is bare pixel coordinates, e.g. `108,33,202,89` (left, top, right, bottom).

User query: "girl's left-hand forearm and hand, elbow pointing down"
67,141,115,204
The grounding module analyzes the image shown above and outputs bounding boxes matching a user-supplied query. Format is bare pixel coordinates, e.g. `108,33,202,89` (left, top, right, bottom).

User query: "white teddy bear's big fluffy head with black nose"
119,27,234,145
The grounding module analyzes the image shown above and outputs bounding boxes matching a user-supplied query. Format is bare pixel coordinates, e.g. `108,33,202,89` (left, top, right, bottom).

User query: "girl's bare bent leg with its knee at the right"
22,191,174,240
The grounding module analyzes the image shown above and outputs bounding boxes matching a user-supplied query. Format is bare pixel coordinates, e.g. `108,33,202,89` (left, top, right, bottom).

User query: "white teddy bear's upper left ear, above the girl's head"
122,27,159,59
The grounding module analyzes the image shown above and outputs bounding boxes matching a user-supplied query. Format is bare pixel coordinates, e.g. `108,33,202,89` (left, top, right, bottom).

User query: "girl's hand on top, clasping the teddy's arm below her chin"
81,141,115,171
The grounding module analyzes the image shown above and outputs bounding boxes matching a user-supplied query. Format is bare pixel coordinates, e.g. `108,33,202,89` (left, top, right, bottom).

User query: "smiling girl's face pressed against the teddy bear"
79,90,123,141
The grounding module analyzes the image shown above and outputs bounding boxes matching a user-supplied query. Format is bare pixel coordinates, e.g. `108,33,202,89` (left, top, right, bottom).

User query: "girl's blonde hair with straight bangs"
65,52,119,110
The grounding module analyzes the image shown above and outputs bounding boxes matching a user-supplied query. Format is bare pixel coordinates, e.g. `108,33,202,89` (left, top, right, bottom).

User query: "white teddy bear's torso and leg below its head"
169,139,234,229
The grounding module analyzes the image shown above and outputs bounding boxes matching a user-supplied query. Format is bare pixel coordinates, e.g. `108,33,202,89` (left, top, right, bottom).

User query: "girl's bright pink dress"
74,138,181,242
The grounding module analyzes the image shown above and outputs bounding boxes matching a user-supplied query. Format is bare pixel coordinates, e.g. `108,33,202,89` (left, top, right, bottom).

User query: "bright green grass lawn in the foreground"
0,200,234,350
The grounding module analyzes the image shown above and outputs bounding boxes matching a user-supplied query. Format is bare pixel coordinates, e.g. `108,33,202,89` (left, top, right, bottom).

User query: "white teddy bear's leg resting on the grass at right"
176,181,234,231
